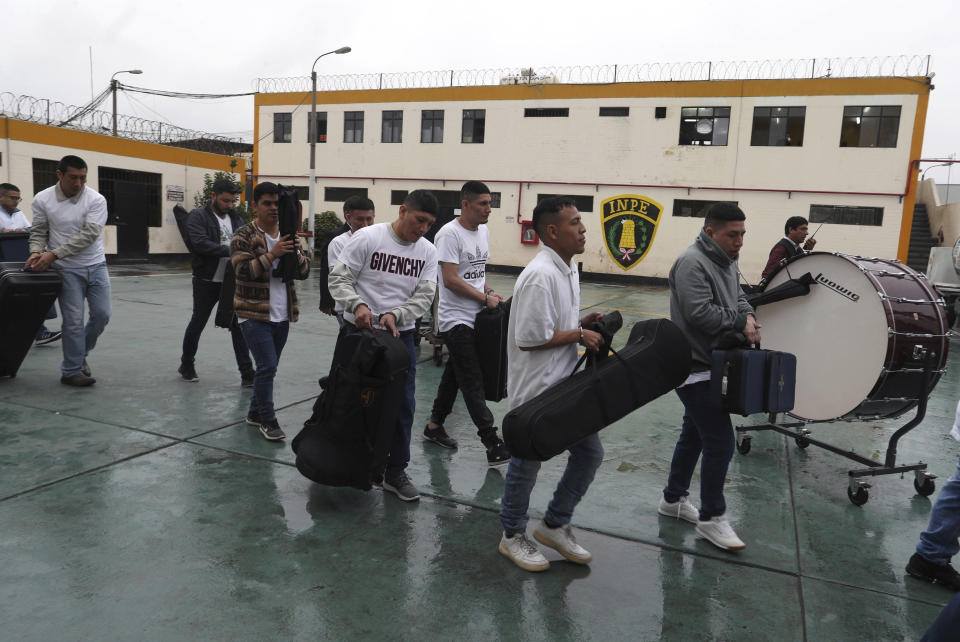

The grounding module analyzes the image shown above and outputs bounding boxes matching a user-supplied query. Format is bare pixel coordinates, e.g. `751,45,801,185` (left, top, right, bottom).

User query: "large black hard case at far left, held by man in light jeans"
0,263,60,377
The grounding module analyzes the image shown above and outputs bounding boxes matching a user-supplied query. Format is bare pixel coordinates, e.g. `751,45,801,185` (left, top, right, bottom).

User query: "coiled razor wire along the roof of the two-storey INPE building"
253,55,930,93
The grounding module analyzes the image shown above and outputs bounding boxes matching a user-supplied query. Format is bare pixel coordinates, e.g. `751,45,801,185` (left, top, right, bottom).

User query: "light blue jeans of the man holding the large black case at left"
57,262,111,377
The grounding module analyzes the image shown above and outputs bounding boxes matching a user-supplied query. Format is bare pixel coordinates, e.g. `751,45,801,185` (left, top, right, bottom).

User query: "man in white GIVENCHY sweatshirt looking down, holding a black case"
329,189,438,501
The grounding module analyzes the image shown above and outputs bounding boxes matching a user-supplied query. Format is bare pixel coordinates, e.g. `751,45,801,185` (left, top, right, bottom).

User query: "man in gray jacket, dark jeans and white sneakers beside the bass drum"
658,203,760,551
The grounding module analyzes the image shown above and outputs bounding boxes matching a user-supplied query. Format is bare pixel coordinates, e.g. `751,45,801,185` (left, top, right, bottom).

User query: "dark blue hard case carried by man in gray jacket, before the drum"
710,348,797,416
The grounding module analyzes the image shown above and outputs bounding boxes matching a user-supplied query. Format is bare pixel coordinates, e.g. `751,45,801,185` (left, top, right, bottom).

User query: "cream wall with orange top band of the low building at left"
0,118,247,258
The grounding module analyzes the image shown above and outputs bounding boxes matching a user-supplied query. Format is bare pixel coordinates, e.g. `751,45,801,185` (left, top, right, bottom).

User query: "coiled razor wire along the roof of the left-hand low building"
0,92,241,155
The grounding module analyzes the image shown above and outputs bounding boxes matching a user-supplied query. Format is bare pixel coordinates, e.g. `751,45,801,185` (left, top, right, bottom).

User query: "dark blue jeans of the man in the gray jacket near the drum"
663,381,735,520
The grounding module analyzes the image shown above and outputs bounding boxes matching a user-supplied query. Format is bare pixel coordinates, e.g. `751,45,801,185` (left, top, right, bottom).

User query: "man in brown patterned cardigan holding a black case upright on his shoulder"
230,182,310,441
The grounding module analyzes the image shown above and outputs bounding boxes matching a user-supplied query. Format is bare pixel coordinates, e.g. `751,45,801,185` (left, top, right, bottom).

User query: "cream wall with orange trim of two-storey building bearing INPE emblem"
253,77,930,282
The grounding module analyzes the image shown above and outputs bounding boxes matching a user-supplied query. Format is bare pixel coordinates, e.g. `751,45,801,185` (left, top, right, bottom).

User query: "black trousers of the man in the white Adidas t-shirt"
430,324,497,448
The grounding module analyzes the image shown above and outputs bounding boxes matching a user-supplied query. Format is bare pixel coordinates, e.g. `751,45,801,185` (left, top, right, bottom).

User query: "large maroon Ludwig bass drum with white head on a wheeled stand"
757,252,949,421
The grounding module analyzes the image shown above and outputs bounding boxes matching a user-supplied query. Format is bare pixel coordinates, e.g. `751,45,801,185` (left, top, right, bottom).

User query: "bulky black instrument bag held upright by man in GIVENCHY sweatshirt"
292,330,410,490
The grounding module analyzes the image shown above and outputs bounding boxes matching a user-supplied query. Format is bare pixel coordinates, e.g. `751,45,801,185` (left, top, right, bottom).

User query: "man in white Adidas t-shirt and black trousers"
423,181,510,466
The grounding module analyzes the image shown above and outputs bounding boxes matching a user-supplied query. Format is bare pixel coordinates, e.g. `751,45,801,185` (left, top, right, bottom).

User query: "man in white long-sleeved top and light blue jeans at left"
25,156,111,387
